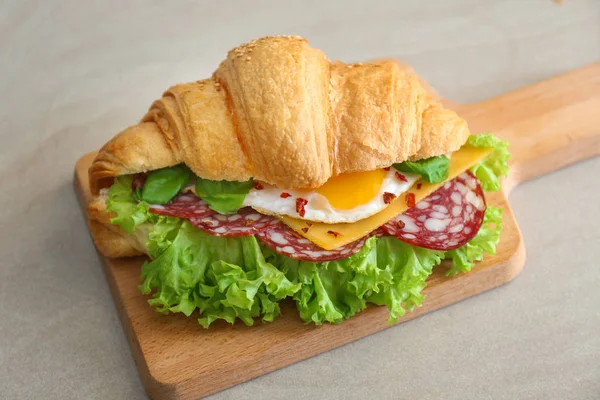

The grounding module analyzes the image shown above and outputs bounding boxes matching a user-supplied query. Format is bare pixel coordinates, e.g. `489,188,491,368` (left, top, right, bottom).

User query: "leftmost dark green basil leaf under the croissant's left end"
142,164,192,204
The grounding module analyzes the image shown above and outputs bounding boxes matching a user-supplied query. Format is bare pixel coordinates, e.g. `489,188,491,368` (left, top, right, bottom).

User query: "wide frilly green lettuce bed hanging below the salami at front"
140,217,444,328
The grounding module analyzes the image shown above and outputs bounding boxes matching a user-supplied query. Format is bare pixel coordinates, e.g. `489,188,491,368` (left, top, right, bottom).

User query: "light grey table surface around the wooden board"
0,0,600,400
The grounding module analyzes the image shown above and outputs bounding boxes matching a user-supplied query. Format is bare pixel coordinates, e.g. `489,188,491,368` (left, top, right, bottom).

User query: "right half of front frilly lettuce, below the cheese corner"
263,237,444,325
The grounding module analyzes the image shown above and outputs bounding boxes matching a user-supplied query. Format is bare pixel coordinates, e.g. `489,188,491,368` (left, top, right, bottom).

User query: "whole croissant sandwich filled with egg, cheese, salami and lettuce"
88,37,509,327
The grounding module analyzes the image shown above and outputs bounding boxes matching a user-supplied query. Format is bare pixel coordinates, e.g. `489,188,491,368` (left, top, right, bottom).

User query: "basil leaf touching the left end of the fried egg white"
196,177,254,214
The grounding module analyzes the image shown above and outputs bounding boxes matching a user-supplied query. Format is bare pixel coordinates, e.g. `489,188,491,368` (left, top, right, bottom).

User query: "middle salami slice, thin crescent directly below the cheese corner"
258,223,369,262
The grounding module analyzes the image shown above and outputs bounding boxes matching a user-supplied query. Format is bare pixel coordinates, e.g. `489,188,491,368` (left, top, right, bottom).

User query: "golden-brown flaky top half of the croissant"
89,37,470,195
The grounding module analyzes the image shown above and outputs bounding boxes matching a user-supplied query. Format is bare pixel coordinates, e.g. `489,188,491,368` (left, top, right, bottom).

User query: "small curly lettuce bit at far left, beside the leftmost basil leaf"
106,175,154,233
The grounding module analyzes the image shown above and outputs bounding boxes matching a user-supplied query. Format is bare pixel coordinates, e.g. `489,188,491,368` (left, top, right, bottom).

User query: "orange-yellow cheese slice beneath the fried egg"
282,146,492,250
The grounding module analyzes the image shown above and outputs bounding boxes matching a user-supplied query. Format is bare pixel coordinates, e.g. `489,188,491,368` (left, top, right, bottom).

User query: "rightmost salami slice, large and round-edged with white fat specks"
382,171,486,250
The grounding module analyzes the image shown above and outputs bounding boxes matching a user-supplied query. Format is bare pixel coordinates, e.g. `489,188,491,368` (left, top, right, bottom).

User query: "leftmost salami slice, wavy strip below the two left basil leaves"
150,193,279,236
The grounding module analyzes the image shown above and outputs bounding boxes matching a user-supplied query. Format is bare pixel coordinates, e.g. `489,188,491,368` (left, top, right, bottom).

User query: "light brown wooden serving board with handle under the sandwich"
75,63,600,399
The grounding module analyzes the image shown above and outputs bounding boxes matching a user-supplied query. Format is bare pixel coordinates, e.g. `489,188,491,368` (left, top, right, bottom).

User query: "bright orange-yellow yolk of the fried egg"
315,169,386,210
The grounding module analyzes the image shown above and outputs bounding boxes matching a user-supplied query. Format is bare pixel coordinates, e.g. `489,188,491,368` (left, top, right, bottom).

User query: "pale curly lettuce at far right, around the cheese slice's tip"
467,133,510,192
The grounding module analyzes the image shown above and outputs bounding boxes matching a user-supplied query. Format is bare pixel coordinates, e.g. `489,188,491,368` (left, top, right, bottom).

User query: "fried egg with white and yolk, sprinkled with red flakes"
243,168,420,224
